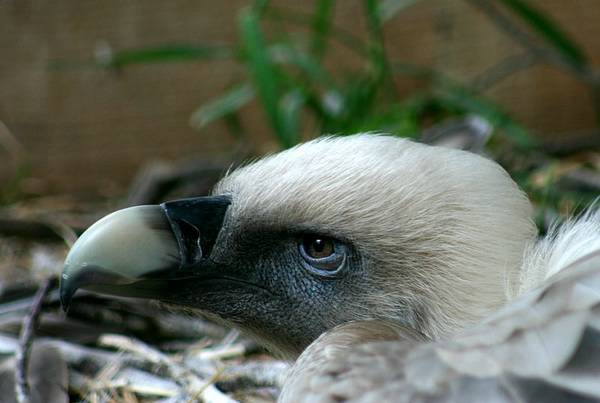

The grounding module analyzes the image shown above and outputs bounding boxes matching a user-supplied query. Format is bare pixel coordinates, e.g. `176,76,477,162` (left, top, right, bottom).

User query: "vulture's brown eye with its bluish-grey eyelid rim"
299,235,346,276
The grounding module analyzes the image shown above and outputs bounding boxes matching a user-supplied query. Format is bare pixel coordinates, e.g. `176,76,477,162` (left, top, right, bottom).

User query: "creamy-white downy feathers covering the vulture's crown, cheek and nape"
215,134,536,338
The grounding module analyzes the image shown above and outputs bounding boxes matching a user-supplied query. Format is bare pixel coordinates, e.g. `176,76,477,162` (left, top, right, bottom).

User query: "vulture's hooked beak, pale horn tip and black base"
60,196,231,310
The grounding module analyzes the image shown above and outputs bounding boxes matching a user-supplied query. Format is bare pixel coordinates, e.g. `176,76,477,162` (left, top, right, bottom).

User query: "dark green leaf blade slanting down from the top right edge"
500,0,587,67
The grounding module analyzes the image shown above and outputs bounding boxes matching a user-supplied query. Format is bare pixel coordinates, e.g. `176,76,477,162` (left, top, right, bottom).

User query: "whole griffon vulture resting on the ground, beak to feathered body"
61,134,600,402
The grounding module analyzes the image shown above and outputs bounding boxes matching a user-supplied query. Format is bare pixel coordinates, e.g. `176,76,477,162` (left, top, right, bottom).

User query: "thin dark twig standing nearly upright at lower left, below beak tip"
15,279,52,403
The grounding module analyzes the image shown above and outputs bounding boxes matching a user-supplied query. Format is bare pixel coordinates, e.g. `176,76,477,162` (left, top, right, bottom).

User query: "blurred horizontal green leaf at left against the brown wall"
101,45,233,68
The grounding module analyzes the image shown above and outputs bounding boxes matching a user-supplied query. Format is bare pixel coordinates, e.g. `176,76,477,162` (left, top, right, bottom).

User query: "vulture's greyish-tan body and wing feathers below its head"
280,252,600,403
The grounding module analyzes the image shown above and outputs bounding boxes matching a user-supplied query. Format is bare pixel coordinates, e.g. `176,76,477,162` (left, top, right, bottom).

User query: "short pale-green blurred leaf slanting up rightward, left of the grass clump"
190,83,254,129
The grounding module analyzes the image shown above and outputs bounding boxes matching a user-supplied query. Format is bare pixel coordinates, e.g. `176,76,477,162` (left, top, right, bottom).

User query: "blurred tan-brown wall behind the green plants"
0,0,600,200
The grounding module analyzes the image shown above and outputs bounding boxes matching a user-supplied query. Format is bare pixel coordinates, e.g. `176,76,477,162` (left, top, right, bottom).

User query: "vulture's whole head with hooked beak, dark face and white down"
61,134,536,358
